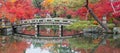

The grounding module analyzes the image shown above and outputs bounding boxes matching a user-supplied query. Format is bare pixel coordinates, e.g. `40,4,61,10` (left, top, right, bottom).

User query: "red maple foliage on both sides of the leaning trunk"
65,0,120,20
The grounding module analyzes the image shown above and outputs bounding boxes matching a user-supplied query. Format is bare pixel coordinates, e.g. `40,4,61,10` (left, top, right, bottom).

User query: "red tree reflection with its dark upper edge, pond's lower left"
0,36,29,53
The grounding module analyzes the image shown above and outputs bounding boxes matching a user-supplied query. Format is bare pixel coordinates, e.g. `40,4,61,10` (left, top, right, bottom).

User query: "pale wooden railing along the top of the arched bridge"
16,18,75,25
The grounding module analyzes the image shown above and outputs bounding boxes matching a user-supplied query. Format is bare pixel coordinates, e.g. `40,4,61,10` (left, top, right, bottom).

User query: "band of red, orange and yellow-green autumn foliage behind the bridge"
0,0,120,22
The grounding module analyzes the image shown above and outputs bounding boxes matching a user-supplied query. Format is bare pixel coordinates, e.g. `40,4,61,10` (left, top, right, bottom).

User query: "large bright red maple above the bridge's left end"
0,0,37,22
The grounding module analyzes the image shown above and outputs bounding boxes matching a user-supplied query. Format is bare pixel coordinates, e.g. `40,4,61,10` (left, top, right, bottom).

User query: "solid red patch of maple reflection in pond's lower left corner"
0,36,29,53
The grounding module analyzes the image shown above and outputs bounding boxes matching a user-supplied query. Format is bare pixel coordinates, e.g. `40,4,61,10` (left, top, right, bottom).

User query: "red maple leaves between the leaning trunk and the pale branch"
89,1,113,19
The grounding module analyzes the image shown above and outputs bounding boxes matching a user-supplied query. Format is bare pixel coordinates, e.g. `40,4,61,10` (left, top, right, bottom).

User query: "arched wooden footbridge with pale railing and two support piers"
14,18,75,37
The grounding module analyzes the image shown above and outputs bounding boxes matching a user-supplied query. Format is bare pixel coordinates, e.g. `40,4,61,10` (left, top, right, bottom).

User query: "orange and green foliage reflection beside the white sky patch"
28,39,71,53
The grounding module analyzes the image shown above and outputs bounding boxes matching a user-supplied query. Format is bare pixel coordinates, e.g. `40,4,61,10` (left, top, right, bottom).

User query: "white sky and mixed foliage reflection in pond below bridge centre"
26,39,72,53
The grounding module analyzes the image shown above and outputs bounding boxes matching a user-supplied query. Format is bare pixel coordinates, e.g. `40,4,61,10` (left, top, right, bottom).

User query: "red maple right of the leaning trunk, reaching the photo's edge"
89,0,120,19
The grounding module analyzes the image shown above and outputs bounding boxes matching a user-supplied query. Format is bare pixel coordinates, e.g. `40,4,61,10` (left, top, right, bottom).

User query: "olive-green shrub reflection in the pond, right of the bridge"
69,38,97,49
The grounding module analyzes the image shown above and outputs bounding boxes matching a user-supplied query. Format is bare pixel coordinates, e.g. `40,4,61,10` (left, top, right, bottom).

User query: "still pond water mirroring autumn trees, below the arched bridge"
0,34,120,53
